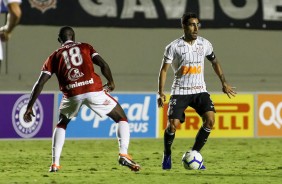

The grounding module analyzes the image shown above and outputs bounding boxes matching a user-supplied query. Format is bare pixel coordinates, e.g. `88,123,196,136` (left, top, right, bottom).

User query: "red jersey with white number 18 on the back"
42,41,103,98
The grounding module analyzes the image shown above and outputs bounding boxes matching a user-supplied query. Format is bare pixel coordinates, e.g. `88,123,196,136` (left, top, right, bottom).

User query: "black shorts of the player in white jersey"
167,92,215,123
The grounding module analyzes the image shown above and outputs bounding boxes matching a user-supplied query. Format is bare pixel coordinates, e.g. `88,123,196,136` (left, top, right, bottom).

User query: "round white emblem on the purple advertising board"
12,95,43,138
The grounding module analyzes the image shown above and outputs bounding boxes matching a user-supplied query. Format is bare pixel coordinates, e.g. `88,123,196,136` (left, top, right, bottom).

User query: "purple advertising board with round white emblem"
0,94,54,138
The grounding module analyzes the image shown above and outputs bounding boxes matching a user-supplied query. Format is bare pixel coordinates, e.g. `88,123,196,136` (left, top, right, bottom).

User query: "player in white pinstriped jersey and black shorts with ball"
158,12,236,170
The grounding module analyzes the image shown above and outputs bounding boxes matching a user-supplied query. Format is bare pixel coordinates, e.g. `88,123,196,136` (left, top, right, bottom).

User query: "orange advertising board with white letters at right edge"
256,94,282,137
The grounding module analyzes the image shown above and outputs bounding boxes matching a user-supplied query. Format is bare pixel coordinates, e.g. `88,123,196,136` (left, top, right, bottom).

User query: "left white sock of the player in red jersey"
52,128,66,166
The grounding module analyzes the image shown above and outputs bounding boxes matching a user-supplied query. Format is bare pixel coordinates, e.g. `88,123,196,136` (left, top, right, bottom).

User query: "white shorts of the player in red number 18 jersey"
60,91,118,119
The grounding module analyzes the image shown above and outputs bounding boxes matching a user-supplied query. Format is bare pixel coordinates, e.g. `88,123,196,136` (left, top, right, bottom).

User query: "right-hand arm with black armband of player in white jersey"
207,52,236,98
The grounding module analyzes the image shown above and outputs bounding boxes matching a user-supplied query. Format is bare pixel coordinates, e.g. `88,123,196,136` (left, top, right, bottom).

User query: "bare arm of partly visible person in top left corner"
0,2,22,41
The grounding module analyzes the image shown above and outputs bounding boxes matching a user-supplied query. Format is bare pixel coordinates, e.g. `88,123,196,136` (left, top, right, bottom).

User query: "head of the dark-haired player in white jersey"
181,12,200,40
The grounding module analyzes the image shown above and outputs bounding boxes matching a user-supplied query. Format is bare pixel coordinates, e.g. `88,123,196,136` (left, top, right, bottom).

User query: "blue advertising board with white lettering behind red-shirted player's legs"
58,94,157,138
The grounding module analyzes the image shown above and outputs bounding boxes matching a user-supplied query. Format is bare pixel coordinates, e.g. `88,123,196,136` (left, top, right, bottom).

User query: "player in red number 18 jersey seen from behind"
23,26,140,172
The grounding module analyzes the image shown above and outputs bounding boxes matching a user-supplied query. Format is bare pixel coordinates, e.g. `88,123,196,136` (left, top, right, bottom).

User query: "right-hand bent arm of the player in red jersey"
92,55,115,91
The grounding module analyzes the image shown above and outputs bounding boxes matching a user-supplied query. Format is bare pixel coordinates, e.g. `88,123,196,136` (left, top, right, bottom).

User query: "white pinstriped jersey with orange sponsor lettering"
163,36,213,95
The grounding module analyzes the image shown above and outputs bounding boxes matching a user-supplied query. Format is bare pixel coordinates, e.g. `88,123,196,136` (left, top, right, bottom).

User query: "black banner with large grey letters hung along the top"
20,0,282,30
